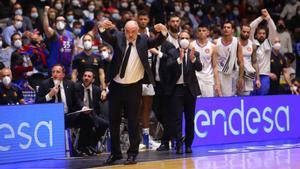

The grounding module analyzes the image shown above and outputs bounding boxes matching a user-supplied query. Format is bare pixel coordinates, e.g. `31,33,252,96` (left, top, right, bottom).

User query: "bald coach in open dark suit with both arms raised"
99,20,167,164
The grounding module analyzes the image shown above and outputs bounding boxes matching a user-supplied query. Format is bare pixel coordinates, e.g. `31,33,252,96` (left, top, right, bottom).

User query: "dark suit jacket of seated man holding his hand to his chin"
35,78,81,113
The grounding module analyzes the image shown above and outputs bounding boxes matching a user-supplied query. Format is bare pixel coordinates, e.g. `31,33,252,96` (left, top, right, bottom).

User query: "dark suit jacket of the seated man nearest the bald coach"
75,83,101,115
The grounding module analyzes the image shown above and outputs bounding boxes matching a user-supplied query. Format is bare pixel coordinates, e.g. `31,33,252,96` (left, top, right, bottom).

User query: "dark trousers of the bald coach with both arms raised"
109,81,142,156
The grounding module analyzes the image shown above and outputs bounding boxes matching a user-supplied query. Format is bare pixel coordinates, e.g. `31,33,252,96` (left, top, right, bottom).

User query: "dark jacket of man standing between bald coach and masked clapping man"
151,41,175,94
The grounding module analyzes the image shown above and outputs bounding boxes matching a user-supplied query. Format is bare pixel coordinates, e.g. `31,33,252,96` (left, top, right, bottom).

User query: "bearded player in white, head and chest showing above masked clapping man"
167,15,181,48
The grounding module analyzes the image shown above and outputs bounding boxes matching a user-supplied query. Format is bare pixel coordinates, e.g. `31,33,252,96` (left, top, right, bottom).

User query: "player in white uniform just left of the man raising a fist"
238,25,261,96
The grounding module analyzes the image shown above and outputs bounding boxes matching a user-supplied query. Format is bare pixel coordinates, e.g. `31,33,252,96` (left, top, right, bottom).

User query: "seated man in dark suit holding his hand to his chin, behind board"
35,64,83,128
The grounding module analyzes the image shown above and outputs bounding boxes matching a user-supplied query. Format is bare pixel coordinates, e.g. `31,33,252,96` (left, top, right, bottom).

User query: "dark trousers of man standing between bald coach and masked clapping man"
153,82,175,144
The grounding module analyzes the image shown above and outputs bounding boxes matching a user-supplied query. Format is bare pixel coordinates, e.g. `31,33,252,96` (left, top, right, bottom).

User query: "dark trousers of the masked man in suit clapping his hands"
170,85,197,146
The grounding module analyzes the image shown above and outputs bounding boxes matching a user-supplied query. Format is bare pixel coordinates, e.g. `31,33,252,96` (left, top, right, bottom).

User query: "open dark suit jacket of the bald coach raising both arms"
100,30,167,85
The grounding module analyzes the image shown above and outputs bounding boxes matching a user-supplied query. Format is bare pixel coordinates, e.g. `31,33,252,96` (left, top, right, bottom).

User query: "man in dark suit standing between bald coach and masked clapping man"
149,31,176,151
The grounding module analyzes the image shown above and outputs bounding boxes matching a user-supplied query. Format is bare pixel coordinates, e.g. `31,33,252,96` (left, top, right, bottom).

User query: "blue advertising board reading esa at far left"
0,104,65,164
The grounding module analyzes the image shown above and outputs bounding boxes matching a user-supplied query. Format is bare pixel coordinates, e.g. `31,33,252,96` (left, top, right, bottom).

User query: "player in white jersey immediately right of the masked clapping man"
191,24,222,97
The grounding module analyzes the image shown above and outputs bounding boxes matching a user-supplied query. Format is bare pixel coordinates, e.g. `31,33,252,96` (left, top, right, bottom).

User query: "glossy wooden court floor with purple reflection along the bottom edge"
97,148,300,169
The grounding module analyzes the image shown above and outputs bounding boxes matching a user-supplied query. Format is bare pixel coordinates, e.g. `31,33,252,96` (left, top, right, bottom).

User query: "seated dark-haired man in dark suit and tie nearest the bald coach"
75,69,108,155
